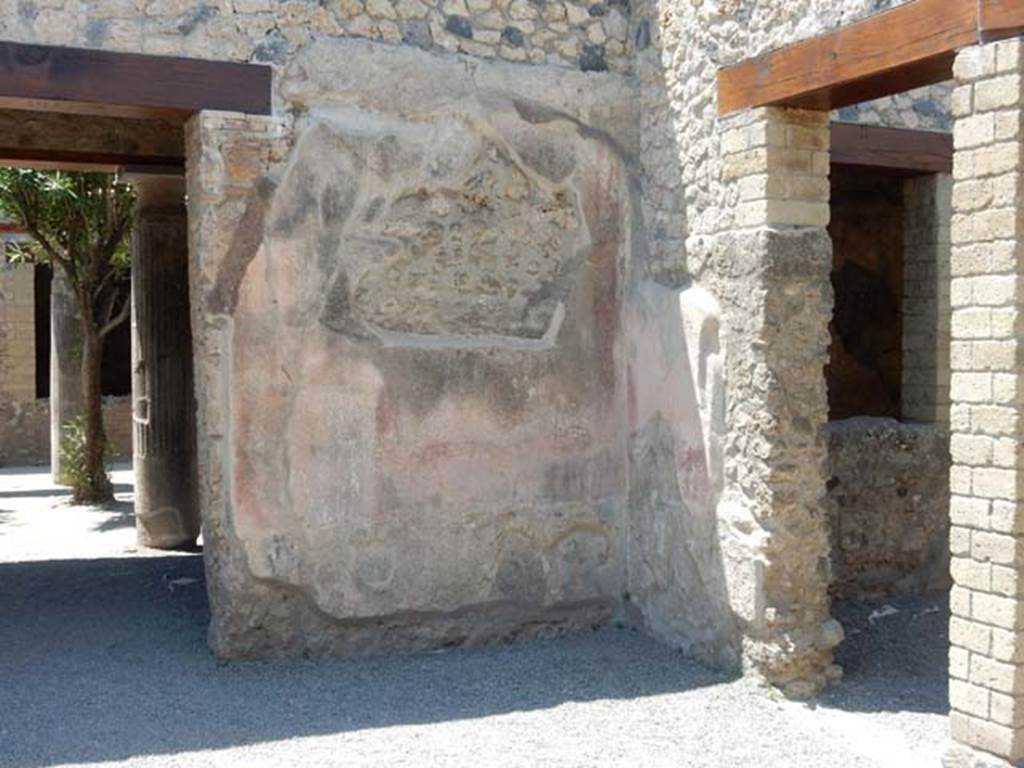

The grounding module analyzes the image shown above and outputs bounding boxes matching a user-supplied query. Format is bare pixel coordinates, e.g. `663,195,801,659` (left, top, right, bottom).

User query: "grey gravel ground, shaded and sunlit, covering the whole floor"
0,471,946,768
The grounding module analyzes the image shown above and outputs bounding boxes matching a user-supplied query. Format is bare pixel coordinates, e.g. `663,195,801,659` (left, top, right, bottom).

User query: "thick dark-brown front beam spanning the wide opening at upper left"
0,42,271,118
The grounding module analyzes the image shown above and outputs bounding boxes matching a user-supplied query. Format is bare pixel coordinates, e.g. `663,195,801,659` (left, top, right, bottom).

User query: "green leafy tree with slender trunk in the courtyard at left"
0,168,135,502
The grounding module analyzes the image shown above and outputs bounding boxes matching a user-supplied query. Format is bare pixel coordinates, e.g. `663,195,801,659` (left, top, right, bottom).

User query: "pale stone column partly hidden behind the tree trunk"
50,267,82,482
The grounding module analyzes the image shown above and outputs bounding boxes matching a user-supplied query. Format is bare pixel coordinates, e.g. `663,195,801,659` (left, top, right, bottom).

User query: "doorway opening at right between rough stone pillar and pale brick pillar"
825,118,952,733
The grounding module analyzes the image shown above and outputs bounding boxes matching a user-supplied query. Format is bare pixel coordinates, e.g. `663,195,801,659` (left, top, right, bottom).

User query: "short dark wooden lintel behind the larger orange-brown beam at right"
830,123,953,175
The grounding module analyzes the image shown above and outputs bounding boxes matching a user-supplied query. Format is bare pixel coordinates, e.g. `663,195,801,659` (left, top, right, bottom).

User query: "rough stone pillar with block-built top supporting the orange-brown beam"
713,109,843,697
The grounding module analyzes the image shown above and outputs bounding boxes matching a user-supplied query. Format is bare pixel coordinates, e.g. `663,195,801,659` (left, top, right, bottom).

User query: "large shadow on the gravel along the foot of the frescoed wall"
0,556,727,766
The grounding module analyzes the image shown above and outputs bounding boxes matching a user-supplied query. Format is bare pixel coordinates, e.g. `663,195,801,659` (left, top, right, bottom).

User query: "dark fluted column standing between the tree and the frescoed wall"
127,173,200,549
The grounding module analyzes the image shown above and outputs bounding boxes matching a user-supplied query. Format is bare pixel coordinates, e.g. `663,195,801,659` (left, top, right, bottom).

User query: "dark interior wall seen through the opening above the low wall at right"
825,167,903,421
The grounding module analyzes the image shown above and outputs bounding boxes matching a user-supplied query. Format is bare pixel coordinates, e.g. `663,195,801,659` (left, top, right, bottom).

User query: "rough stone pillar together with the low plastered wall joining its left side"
628,96,842,695
